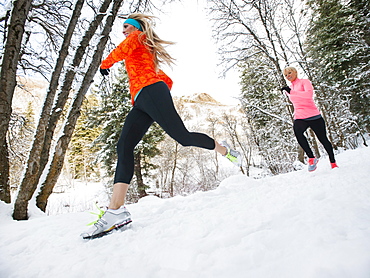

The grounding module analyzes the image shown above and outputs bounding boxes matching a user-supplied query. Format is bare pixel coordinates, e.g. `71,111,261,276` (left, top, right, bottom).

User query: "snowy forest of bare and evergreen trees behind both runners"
0,0,370,220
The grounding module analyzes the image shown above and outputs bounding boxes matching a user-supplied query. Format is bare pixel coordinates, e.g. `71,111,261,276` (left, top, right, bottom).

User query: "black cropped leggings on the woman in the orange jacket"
114,81,215,184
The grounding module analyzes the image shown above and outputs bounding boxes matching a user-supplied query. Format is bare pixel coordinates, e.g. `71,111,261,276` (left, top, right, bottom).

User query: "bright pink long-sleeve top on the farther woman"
287,78,320,120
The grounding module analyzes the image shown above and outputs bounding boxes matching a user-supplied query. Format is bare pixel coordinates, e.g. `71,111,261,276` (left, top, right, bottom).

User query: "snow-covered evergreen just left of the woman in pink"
241,57,297,174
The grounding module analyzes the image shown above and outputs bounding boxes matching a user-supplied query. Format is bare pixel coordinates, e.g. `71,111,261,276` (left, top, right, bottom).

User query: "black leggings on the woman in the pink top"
293,117,335,163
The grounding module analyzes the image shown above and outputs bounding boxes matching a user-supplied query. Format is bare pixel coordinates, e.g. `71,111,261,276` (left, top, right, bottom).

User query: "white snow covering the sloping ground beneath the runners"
0,148,370,278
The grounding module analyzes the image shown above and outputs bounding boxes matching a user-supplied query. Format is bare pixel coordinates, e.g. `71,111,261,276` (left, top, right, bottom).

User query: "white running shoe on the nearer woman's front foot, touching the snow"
81,206,132,239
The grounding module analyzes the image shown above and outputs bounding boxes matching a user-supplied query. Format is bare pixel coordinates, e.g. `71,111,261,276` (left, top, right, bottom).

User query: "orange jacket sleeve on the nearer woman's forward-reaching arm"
100,31,140,69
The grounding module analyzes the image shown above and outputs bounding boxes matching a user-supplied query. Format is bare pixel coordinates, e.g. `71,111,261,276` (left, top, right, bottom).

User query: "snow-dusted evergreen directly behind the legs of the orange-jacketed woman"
90,68,164,201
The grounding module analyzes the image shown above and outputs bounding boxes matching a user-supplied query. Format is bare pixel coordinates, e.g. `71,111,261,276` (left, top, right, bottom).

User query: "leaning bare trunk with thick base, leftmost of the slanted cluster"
13,0,84,220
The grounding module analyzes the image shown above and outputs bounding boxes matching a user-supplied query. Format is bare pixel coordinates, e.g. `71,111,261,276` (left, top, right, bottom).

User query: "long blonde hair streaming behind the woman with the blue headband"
128,13,175,69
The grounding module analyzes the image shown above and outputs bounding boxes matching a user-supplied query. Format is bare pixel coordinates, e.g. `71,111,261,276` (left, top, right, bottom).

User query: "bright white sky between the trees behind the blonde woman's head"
114,0,240,104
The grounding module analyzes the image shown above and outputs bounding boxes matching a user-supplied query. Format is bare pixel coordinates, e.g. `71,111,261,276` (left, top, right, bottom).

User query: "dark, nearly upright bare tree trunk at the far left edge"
0,0,32,203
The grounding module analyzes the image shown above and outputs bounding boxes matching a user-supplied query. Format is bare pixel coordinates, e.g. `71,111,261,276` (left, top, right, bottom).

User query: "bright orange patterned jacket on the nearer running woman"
100,30,173,104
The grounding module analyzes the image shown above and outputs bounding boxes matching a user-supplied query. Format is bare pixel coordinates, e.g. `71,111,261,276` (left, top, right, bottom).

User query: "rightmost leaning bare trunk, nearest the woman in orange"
36,0,123,211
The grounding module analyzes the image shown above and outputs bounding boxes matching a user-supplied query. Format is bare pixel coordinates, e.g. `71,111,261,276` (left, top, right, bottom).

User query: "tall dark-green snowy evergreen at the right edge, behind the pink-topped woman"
307,0,370,137
